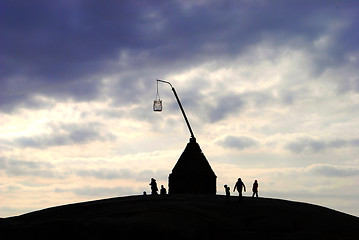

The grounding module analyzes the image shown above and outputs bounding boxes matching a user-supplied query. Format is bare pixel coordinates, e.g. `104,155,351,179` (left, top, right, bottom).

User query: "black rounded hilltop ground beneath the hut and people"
0,195,359,240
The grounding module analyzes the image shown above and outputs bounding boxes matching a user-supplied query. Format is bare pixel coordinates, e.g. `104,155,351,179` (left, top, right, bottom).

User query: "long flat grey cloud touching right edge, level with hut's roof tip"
285,137,359,153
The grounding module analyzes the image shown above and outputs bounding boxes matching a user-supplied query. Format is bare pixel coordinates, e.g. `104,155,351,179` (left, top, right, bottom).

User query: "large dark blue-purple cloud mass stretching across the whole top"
0,1,359,112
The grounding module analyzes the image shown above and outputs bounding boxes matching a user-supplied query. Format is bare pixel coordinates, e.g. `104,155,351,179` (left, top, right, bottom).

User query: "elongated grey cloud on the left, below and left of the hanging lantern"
14,123,115,148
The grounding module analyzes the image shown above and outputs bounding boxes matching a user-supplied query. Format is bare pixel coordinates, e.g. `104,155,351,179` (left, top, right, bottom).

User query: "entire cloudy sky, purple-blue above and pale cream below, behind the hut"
0,0,359,217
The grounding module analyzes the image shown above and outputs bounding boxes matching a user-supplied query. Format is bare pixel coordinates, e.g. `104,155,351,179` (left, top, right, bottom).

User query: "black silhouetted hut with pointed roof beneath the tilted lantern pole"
168,138,217,194
